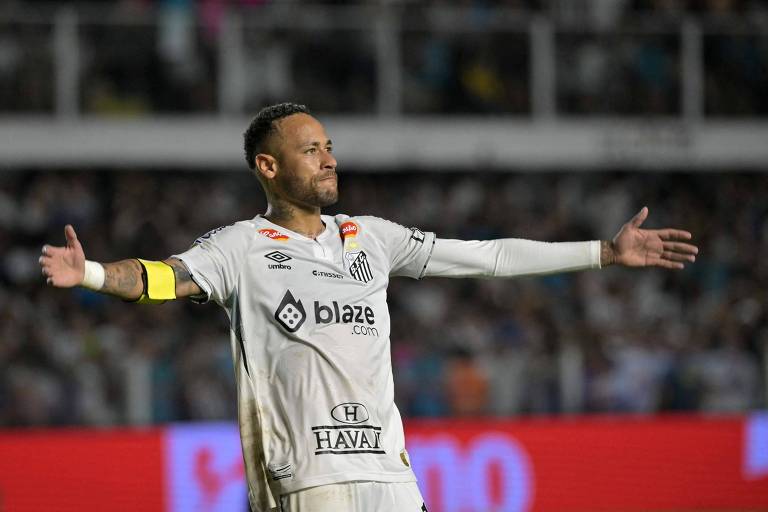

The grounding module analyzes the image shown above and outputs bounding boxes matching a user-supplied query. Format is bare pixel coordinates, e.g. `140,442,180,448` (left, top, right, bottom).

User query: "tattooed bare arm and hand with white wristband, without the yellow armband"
39,224,203,301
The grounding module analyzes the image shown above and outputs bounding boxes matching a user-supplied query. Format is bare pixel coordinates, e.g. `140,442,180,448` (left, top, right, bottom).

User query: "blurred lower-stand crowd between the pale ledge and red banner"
0,169,768,426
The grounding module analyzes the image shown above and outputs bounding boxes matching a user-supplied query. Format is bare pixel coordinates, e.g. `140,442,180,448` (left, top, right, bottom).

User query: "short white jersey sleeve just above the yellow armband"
172,223,253,305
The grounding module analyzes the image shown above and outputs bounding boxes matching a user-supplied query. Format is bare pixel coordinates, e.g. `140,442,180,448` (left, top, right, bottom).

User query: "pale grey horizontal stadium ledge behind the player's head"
0,117,768,172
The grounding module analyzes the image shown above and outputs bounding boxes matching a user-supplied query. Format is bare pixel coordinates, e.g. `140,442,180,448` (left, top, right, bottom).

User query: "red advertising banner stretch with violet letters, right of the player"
406,414,768,512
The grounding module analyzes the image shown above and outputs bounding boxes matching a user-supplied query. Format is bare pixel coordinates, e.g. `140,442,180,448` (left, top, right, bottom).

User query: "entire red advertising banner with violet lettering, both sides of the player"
0,413,768,512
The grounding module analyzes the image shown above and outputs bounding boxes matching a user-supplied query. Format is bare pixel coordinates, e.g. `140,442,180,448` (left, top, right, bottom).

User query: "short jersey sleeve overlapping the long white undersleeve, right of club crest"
361,217,435,279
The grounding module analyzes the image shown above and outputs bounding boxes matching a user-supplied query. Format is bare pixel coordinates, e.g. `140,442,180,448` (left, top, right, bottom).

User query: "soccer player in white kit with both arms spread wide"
40,103,698,512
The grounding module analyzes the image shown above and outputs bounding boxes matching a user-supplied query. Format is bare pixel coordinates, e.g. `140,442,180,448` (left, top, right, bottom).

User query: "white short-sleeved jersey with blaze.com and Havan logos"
174,215,435,511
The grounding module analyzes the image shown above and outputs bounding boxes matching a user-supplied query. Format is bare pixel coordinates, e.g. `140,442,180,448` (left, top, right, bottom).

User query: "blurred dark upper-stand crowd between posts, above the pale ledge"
0,0,768,117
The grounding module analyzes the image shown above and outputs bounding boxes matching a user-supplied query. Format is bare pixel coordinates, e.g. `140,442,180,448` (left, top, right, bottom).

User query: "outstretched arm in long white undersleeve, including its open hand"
424,208,698,277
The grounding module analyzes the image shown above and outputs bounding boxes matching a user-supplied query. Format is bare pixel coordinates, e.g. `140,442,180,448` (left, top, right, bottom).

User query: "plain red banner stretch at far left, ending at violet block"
0,429,165,512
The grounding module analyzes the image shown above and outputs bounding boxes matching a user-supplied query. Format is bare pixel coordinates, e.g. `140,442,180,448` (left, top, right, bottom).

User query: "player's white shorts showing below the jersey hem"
277,482,427,512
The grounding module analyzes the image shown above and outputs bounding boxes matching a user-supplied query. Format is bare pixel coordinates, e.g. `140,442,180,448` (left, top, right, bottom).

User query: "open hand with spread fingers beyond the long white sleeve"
602,207,699,270
